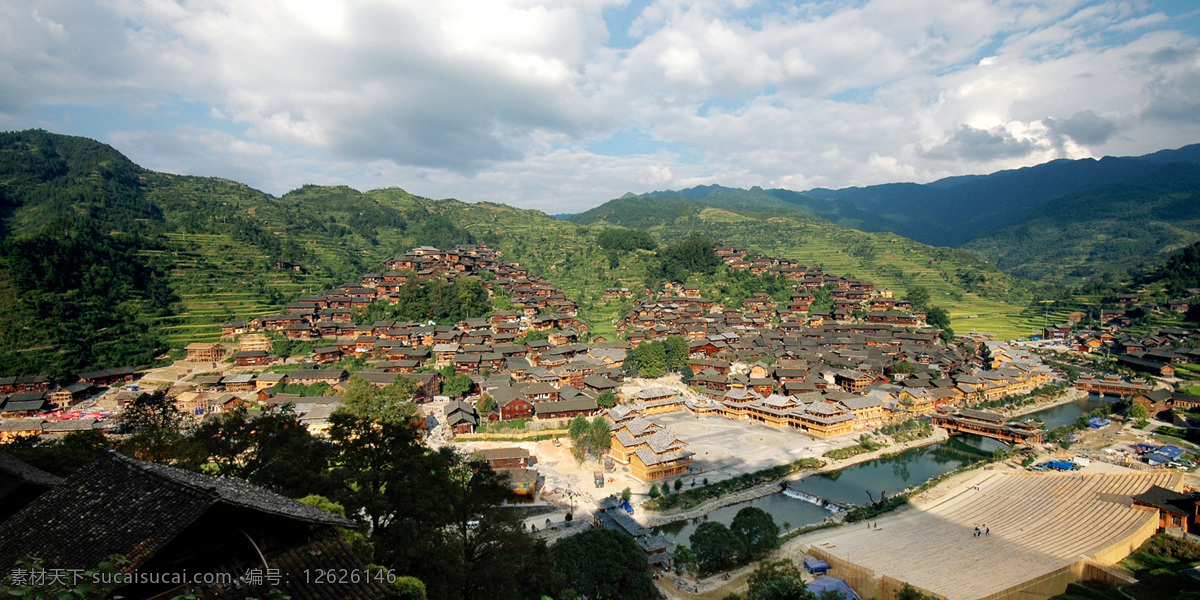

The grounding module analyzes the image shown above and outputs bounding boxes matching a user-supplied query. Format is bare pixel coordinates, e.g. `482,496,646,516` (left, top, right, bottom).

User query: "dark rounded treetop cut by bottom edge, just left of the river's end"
550,529,659,600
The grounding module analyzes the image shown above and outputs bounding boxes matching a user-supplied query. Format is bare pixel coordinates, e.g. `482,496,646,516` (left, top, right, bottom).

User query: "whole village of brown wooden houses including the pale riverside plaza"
0,240,1200,600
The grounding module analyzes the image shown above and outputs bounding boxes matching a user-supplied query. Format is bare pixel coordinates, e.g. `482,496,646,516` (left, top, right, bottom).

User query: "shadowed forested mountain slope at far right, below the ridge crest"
964,163,1200,282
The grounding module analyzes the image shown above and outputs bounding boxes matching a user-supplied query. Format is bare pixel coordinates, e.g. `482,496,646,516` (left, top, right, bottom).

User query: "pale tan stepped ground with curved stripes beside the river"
806,472,1180,600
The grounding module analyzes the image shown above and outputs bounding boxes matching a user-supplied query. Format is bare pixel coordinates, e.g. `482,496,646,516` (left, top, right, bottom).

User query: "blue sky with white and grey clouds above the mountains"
0,0,1200,214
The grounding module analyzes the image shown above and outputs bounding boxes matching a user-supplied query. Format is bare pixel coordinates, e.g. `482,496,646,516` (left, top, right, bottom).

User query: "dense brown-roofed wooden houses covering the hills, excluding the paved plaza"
9,238,1195,458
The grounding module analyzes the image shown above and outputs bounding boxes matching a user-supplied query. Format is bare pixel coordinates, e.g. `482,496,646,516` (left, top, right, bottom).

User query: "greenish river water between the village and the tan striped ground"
655,396,1106,544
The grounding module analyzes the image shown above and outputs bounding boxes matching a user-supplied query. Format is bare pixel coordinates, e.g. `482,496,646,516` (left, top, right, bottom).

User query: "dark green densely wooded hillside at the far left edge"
0,131,174,374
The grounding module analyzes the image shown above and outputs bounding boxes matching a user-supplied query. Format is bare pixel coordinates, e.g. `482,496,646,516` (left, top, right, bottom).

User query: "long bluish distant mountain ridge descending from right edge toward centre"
569,144,1200,281
